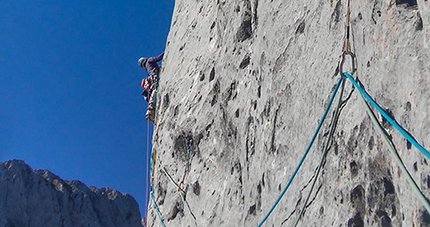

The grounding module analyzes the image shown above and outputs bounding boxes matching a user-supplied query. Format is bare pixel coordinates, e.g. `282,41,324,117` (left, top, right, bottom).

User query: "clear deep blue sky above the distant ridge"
0,0,174,216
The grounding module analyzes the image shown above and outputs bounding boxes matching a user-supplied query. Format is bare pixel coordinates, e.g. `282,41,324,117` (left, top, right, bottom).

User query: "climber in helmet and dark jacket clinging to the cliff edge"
137,53,164,122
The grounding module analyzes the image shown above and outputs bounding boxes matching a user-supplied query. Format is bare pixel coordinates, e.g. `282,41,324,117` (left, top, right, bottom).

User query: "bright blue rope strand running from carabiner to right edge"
343,72,430,159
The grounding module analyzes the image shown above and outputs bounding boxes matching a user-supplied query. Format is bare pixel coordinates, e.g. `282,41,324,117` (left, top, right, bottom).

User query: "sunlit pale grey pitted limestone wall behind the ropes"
148,0,430,226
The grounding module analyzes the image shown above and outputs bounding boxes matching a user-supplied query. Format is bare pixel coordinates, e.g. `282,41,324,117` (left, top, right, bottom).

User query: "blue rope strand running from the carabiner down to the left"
258,77,343,227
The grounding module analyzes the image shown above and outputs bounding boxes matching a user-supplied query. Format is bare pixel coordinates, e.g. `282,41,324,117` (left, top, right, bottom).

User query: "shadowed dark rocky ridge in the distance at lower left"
0,160,142,227
